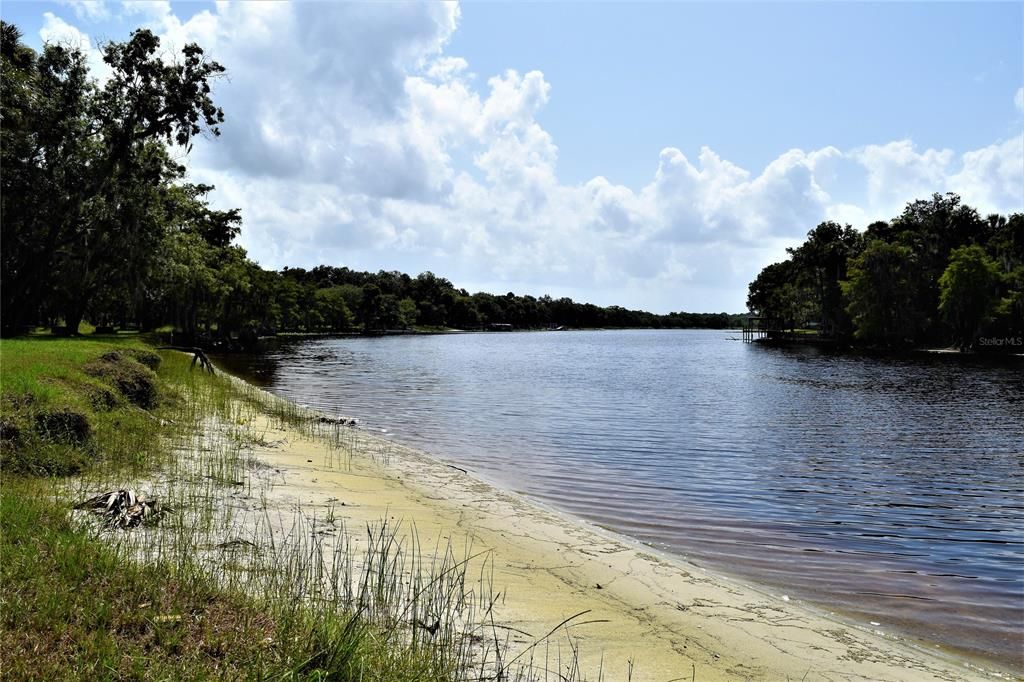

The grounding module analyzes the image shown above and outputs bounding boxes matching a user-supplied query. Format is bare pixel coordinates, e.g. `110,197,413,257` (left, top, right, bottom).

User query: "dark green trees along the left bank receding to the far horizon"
0,23,741,338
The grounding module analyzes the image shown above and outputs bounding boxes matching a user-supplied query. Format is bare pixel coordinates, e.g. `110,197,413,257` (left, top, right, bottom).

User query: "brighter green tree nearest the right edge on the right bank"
939,244,999,349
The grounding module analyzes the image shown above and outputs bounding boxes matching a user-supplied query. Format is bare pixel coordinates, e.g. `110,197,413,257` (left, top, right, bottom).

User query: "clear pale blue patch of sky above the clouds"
450,3,1024,184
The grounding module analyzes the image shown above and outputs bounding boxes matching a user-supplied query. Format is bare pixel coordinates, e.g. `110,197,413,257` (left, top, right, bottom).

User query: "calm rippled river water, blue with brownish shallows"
216,331,1024,668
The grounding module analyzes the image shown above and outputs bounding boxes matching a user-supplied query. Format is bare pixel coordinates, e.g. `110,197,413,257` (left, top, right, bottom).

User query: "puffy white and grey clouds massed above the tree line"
44,2,1024,311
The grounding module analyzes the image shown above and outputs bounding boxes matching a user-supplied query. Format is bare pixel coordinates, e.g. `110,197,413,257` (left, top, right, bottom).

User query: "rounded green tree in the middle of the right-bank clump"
842,240,924,346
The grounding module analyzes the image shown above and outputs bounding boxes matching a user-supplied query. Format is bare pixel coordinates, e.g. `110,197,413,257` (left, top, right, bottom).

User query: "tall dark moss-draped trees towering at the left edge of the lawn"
0,24,224,332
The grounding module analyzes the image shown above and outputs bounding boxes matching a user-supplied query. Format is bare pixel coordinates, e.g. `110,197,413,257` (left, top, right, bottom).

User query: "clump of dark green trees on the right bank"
746,194,1024,349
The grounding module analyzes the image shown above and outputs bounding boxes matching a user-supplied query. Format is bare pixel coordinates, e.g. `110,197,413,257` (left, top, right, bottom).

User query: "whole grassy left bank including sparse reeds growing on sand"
0,337,557,680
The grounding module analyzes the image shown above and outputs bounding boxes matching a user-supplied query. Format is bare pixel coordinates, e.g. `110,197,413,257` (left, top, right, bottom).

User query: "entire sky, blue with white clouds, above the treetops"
6,1,1024,312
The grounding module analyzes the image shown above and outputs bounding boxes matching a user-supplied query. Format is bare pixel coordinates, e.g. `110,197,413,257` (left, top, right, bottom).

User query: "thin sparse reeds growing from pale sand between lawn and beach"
54,352,603,682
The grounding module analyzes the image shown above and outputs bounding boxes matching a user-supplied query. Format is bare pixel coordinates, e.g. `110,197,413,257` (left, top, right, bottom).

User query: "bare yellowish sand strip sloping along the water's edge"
224,405,1017,682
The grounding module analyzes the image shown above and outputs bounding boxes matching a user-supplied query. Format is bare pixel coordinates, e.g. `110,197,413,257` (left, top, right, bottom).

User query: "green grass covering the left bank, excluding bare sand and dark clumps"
0,336,452,680
